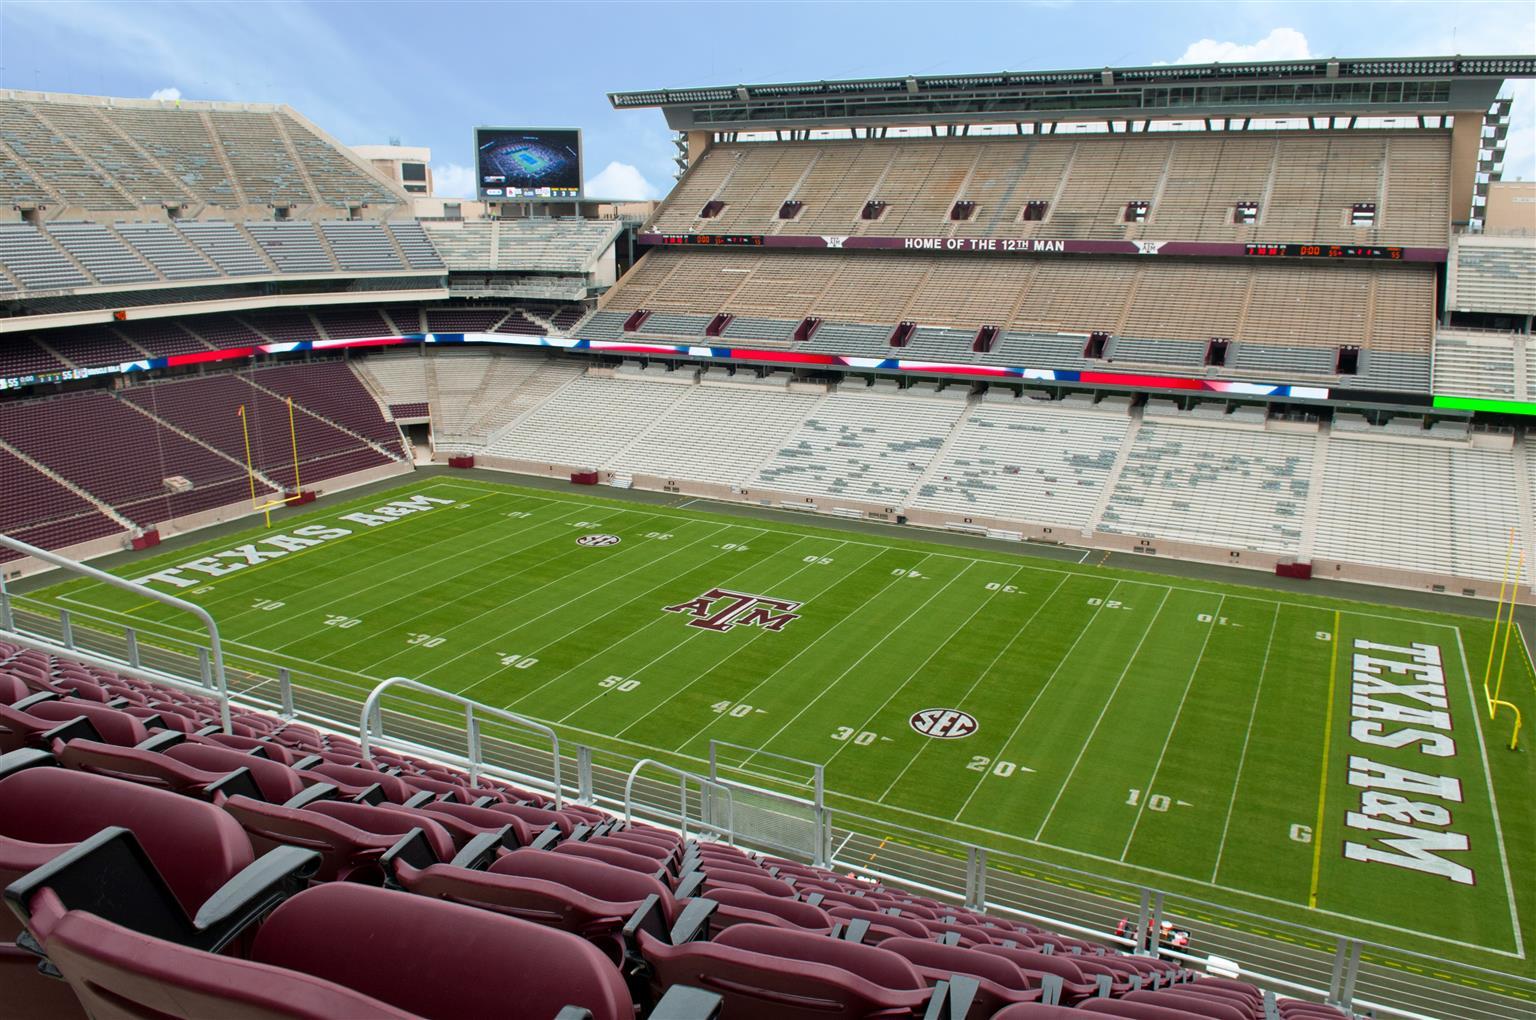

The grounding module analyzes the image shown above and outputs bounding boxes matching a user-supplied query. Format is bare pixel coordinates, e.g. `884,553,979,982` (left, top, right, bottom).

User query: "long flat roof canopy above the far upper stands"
608,55,1536,131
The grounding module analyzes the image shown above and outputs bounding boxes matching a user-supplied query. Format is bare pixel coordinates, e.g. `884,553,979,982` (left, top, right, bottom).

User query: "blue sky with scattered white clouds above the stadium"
0,0,1536,198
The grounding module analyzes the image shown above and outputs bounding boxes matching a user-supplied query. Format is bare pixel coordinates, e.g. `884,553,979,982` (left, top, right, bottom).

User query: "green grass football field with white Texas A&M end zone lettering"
21,476,1536,974
